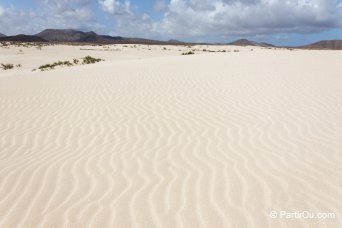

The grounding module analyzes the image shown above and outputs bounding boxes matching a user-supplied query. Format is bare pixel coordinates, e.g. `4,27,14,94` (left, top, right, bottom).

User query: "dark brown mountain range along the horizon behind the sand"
0,29,342,50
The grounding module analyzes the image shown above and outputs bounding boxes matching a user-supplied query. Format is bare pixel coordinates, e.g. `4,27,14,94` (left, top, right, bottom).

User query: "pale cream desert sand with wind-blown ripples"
0,45,342,228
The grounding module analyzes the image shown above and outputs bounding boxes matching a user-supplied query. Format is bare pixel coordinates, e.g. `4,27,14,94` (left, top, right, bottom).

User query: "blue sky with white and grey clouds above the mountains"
0,0,342,46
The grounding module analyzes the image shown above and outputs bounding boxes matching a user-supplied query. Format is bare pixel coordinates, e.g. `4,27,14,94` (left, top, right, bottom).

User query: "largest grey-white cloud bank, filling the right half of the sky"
152,0,342,37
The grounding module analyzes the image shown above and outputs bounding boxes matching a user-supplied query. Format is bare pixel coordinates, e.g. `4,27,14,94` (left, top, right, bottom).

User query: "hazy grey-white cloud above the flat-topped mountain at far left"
0,0,101,35
